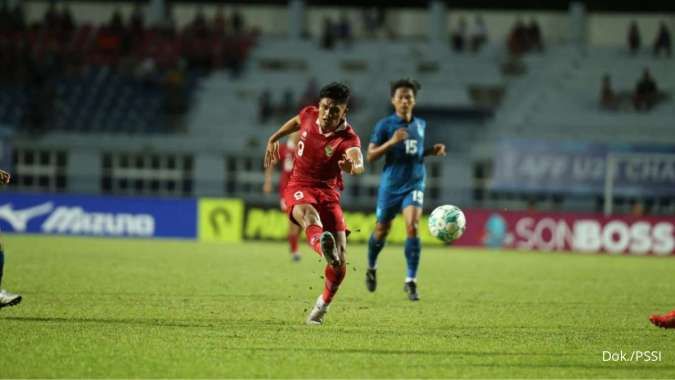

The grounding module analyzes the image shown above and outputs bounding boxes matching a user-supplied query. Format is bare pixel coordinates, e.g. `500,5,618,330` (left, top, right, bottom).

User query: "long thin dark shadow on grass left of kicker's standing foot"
0,316,285,328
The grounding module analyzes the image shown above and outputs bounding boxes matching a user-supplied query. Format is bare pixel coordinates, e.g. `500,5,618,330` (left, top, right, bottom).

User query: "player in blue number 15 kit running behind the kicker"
366,79,445,301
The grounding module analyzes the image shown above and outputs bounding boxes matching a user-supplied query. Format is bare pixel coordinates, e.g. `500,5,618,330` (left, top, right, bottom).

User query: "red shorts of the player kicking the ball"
283,186,347,232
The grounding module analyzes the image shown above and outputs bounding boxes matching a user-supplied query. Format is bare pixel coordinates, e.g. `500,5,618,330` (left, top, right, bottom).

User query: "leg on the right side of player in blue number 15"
403,200,422,301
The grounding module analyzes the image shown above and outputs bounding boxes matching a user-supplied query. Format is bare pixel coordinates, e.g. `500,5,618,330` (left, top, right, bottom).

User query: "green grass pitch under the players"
0,236,675,378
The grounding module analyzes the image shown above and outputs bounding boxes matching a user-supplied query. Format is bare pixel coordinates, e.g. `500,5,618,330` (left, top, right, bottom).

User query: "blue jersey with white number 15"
370,113,427,194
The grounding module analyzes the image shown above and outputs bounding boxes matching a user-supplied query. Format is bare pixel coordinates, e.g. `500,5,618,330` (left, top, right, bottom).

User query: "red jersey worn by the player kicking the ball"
288,106,361,191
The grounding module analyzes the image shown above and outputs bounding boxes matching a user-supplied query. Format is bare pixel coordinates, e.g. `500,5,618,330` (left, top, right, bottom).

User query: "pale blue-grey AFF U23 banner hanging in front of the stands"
491,139,675,196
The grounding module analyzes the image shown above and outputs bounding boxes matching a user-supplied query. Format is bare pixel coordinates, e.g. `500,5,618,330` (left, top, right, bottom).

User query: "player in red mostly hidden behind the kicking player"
263,132,301,262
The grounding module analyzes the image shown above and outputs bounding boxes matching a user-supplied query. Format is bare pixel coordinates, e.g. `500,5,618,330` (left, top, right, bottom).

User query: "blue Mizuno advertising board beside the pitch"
0,192,197,239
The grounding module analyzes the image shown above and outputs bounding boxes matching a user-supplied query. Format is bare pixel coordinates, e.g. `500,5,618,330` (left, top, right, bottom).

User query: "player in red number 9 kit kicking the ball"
265,82,364,324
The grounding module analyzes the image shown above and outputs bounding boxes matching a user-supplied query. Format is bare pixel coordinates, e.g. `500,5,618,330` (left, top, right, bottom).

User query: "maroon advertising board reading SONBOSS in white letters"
454,210,675,256
